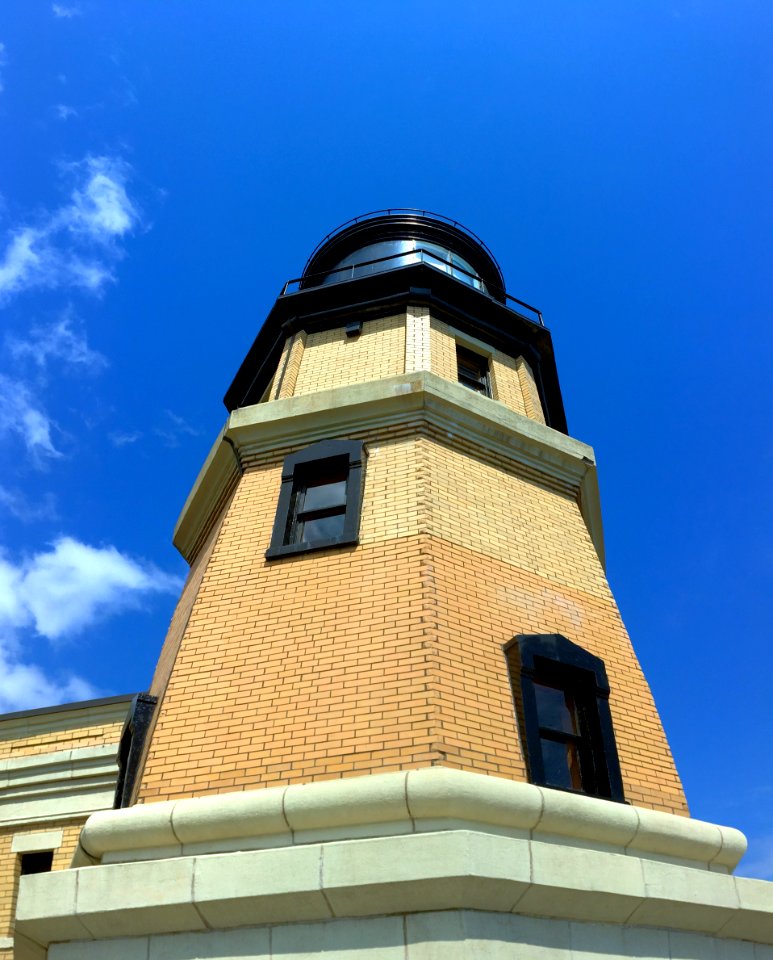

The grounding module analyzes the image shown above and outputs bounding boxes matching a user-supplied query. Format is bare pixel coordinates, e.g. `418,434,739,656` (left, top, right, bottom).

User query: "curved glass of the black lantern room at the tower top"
322,238,486,292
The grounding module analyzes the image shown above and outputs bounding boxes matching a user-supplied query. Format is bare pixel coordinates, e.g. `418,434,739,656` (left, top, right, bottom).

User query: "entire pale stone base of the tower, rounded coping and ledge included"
16,767,773,960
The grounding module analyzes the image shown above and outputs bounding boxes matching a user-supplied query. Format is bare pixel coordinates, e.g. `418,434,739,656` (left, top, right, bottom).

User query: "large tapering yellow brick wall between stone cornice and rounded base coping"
140,429,686,813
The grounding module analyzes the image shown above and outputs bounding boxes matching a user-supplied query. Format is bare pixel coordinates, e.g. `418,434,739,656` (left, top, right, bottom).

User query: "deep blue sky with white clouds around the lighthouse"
0,0,773,877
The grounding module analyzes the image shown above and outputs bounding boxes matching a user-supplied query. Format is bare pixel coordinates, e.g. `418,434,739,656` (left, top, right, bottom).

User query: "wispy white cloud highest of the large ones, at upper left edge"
0,156,139,303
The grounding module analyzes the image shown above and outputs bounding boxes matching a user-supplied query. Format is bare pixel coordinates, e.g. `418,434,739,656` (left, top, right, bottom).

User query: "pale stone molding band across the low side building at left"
0,743,118,826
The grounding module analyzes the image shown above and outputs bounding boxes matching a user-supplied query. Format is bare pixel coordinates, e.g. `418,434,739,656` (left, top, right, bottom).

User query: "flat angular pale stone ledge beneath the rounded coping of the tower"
16,829,773,957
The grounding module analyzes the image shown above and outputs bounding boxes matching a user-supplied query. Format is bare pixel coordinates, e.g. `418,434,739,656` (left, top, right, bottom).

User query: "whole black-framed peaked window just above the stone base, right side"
506,634,623,801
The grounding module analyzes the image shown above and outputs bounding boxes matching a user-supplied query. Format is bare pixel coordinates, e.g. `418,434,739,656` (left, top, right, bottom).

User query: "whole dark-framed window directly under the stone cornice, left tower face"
266,440,363,559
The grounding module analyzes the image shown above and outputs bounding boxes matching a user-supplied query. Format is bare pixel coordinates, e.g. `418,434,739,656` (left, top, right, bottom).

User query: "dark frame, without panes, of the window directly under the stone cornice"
266,440,365,560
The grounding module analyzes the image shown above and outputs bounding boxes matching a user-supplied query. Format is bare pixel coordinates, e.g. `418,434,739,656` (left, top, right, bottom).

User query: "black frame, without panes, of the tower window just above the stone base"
505,633,625,803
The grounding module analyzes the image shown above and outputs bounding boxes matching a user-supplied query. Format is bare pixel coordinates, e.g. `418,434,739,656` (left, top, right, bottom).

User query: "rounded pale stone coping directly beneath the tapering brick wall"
74,767,746,873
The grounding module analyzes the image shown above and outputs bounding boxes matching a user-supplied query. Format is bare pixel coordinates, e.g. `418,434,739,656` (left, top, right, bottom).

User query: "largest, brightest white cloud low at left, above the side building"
0,537,182,711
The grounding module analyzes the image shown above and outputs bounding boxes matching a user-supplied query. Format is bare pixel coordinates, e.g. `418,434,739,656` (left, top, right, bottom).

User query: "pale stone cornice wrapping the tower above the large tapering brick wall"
174,371,604,564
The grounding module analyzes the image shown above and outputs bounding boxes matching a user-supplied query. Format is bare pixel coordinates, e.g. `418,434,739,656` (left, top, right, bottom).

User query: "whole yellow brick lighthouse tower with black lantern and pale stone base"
17,210,773,960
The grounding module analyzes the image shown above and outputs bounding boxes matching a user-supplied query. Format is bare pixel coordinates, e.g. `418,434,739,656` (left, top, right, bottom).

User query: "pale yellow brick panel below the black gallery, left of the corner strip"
292,314,405,396
